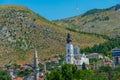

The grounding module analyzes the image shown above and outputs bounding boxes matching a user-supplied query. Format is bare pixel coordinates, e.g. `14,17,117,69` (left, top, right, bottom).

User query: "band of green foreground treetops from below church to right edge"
47,64,120,80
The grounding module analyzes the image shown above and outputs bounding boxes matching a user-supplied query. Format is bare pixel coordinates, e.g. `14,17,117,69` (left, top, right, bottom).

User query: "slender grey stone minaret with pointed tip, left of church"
34,48,39,80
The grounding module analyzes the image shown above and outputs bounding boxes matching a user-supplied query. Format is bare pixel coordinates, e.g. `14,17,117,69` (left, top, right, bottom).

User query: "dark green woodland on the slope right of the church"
81,39,120,57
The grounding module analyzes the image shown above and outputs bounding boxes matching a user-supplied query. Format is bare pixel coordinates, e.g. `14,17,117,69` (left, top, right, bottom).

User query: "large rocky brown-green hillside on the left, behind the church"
0,5,106,65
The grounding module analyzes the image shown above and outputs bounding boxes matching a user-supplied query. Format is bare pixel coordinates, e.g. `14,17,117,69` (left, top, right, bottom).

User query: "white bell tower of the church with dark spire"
65,33,74,64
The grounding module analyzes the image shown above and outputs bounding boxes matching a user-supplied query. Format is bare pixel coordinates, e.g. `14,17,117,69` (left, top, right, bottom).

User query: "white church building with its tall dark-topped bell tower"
65,33,89,69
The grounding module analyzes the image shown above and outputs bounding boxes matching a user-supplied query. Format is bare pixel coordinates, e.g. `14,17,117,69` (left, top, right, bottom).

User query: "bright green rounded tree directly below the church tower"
47,64,77,80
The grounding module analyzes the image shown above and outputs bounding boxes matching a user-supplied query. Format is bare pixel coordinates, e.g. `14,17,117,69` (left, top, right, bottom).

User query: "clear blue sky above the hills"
0,0,120,20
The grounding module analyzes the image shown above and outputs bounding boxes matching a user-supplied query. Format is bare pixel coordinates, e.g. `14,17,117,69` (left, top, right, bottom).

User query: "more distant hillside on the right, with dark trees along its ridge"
53,4,120,38
